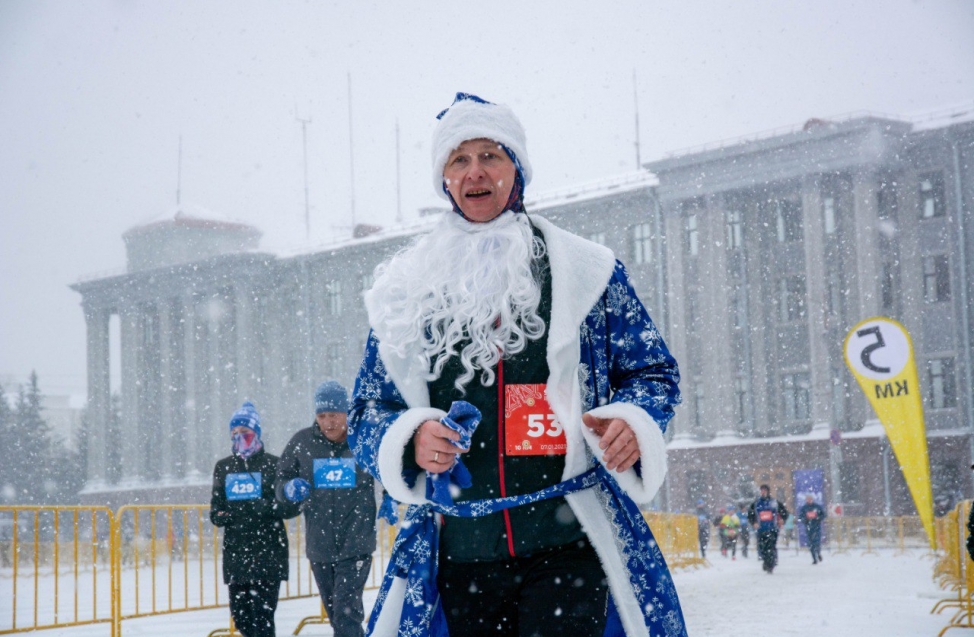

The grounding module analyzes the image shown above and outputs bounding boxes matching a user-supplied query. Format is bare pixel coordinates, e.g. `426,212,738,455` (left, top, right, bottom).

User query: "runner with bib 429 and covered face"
210,402,298,637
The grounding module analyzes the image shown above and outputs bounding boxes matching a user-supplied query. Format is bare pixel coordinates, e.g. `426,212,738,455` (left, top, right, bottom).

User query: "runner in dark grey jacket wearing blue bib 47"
277,380,376,637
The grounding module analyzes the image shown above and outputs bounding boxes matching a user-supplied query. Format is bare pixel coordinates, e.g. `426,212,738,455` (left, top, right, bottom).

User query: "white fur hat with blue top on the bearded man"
432,93,531,199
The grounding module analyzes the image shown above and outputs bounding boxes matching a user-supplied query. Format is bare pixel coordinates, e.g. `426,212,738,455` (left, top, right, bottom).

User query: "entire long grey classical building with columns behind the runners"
72,113,974,514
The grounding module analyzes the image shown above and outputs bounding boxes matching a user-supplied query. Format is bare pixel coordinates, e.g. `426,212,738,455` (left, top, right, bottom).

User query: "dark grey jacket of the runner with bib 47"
277,423,376,562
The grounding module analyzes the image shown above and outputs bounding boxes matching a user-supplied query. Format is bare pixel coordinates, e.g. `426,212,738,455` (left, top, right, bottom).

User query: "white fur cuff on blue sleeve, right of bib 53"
582,403,666,504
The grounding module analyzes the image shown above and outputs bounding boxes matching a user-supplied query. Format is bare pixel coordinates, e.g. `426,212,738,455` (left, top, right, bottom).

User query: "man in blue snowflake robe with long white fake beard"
348,93,686,637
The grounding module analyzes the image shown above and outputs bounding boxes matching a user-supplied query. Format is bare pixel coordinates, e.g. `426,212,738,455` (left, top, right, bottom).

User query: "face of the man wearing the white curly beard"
443,139,517,223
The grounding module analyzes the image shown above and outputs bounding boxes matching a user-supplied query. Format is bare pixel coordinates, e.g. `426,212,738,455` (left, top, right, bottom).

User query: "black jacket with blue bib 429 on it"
210,450,298,584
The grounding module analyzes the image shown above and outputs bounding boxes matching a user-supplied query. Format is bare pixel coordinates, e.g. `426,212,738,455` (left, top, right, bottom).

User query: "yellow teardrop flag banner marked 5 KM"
844,316,936,548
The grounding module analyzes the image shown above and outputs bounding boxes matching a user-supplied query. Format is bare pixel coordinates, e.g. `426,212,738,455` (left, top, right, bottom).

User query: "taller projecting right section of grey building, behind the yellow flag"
646,113,974,515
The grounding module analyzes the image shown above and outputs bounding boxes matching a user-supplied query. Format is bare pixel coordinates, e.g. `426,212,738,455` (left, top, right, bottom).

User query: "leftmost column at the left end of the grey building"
84,304,112,491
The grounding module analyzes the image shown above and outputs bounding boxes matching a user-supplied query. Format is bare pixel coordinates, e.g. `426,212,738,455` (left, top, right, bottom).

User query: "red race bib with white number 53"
504,384,567,456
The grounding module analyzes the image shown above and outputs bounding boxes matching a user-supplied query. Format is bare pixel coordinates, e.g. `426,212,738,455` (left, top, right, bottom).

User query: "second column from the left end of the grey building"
119,305,141,485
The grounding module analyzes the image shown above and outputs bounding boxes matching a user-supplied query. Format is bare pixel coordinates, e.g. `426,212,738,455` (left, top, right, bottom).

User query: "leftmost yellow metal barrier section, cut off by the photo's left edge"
0,506,115,637
